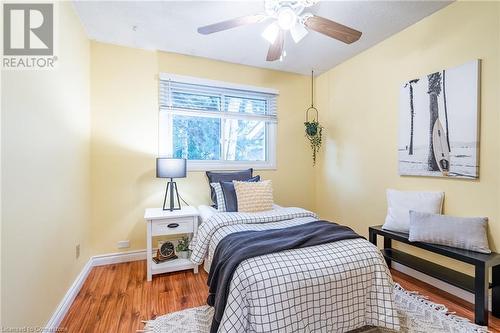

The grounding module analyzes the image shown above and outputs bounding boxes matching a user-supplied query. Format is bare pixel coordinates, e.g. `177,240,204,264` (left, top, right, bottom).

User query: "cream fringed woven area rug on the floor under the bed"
142,284,488,333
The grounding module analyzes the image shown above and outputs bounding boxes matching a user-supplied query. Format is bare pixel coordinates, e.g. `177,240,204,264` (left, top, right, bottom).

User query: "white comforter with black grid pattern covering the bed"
191,208,399,333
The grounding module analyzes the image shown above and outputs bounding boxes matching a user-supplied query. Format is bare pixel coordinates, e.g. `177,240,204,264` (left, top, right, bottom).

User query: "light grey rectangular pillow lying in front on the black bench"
409,211,491,253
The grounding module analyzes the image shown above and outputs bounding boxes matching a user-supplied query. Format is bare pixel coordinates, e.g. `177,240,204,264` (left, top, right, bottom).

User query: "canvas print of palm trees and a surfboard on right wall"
397,60,480,179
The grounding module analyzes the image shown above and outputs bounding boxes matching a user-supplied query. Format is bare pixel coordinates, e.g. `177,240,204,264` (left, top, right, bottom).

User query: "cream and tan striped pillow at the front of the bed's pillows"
233,180,273,212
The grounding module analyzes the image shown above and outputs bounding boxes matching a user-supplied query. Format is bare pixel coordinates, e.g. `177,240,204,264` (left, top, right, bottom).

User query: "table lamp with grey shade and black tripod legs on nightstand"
156,157,186,211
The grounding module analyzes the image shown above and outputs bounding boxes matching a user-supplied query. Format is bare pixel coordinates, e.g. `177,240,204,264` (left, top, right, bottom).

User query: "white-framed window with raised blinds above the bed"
159,74,277,170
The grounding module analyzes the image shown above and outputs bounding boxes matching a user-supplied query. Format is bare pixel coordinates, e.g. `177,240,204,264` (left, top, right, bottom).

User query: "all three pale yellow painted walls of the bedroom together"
1,2,500,326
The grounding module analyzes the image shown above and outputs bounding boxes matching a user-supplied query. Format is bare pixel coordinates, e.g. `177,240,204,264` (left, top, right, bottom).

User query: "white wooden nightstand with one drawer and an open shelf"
144,206,198,281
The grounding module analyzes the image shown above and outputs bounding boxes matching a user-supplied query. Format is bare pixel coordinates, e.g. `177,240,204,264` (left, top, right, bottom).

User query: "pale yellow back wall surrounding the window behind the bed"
91,42,314,253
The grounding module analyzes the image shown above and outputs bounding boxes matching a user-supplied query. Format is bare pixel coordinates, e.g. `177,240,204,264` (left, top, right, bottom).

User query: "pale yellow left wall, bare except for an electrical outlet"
1,3,90,326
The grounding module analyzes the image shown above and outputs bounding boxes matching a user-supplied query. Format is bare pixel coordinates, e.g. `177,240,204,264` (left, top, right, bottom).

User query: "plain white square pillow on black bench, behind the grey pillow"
382,189,444,233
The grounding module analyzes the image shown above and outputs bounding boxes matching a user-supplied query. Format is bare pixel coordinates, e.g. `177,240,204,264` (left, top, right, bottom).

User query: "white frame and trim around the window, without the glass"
158,73,279,171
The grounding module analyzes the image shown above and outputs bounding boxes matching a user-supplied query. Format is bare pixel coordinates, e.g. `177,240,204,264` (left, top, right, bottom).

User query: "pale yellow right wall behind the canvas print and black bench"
316,2,500,272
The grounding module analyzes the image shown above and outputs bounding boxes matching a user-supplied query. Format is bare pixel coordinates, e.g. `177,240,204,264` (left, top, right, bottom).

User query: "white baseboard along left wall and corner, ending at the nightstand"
44,250,146,332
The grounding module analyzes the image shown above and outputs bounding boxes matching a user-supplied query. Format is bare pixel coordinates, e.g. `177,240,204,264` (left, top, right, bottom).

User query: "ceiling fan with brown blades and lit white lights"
198,0,361,61
